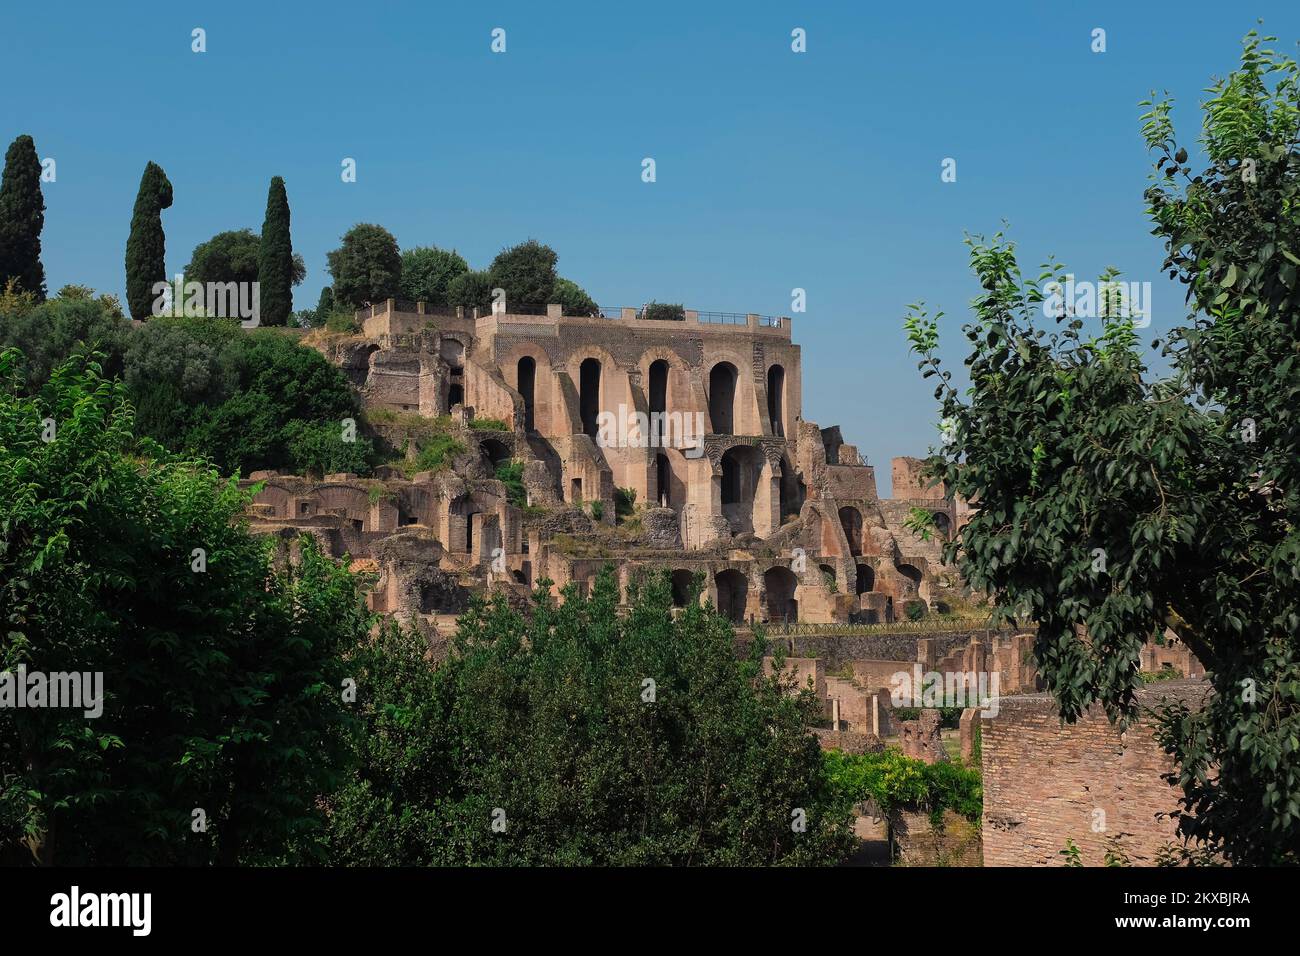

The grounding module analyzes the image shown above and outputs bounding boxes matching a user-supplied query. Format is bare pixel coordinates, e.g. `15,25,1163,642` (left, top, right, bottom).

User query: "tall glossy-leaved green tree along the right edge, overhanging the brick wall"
907,33,1300,864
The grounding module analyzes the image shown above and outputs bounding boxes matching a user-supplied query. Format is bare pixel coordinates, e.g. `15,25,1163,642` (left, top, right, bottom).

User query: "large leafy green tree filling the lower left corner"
0,350,369,865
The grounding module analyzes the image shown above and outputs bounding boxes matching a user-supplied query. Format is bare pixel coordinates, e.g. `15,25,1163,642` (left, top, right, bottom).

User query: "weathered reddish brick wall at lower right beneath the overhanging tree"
982,680,1206,866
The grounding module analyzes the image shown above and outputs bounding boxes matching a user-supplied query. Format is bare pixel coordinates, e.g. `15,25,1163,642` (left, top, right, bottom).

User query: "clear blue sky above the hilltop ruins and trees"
0,0,1300,493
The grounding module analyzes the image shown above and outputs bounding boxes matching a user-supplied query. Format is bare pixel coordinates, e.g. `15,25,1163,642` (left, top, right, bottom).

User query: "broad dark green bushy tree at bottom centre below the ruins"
330,568,852,866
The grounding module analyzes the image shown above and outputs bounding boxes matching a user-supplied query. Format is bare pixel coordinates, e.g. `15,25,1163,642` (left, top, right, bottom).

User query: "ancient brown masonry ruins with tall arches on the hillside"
250,299,965,633
